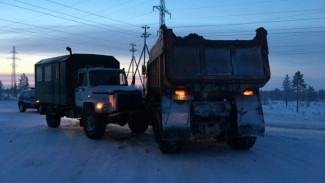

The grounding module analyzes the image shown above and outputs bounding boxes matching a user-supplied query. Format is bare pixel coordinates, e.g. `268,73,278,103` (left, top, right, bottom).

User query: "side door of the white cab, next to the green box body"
75,72,87,107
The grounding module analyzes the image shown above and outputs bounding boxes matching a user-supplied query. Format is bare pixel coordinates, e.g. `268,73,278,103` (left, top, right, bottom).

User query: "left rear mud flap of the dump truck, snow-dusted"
161,96,191,141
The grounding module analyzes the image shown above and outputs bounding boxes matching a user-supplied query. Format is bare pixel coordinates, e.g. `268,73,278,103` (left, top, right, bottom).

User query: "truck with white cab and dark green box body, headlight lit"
35,51,148,139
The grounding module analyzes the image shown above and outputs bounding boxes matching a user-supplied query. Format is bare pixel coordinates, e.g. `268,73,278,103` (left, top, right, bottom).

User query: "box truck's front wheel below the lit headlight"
81,107,106,139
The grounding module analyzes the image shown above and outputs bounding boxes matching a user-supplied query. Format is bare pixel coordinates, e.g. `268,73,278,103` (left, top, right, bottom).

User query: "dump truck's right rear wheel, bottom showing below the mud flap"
226,136,256,150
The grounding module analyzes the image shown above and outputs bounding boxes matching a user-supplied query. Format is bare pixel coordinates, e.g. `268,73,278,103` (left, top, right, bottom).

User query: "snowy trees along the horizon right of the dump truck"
260,71,325,112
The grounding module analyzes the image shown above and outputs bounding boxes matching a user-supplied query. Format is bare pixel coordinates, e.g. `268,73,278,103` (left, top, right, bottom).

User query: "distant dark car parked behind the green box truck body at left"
18,88,39,112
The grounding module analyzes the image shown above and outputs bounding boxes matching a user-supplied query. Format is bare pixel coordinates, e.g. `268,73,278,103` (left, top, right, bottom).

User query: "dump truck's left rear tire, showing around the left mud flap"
152,110,183,154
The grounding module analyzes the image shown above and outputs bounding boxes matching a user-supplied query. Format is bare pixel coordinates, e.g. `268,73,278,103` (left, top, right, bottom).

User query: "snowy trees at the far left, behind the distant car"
0,73,29,100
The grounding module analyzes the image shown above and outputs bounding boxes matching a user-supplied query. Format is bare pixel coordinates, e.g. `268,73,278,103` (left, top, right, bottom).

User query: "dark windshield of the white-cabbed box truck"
89,70,127,86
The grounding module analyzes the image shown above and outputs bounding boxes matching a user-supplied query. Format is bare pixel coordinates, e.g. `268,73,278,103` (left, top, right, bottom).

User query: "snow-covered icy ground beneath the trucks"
0,101,325,183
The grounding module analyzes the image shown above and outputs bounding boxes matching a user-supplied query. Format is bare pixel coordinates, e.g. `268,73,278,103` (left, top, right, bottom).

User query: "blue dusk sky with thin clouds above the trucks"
0,0,325,89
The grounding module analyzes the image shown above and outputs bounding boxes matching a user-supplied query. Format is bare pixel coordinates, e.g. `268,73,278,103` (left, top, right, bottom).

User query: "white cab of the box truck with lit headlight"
75,67,129,114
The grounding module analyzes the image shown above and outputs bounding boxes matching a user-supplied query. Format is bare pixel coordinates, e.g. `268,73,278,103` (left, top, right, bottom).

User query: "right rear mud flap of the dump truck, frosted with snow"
236,95,265,137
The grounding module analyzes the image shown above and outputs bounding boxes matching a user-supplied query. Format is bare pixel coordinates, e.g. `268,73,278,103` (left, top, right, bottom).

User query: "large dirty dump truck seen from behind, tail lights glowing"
145,27,271,153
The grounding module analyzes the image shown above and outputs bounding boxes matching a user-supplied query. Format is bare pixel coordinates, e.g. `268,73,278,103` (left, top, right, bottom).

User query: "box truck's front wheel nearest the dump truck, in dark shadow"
128,112,149,134
